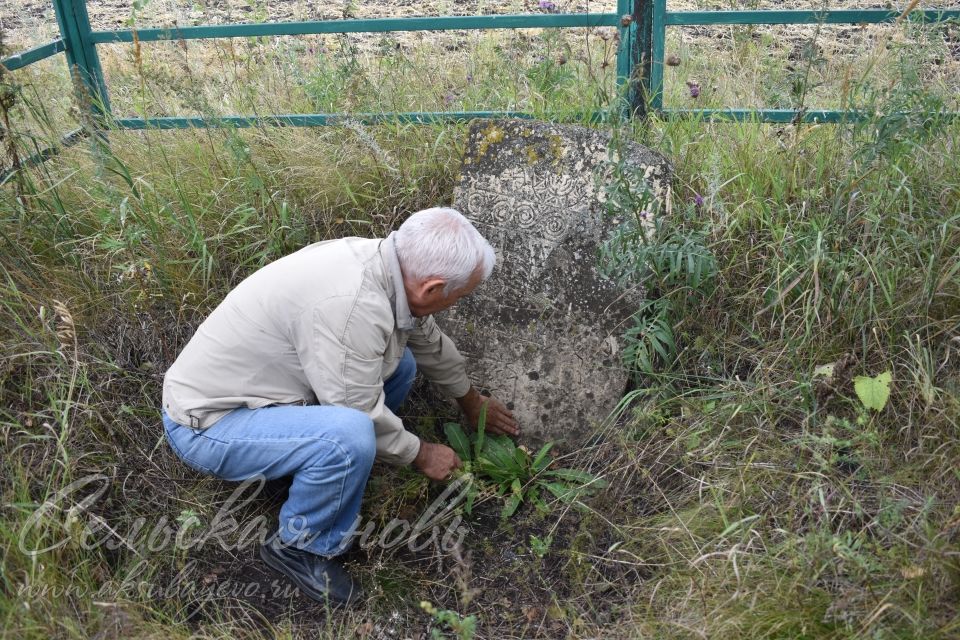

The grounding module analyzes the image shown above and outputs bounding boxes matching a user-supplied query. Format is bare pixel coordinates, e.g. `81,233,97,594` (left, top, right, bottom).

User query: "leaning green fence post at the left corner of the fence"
53,0,110,124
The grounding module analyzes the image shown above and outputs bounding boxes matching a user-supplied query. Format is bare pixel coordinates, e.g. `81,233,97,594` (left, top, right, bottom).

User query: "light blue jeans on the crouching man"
163,349,417,556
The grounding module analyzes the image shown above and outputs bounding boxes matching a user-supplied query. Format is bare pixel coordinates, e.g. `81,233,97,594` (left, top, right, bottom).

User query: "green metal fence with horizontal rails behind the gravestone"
0,0,960,141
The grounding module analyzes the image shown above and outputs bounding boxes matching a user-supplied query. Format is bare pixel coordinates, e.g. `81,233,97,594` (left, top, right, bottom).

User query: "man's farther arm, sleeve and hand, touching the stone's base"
407,316,520,436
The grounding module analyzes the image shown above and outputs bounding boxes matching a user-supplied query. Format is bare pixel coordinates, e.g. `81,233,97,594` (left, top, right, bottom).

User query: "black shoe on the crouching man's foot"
260,536,362,606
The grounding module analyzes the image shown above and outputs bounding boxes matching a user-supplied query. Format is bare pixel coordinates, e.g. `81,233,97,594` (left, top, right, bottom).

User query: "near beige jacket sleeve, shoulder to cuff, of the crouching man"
293,296,420,465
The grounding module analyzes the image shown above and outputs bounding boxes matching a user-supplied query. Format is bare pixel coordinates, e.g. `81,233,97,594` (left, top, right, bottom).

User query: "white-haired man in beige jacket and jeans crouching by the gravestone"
162,208,519,603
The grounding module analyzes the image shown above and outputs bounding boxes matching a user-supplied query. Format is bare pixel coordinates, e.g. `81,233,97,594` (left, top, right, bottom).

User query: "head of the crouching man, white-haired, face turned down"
395,207,496,318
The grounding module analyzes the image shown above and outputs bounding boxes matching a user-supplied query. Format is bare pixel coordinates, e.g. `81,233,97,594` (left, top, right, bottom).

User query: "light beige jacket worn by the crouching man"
163,234,470,464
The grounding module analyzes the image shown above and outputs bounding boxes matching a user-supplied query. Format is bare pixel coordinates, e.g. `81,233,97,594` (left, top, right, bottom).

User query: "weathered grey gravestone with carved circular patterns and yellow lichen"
438,120,671,449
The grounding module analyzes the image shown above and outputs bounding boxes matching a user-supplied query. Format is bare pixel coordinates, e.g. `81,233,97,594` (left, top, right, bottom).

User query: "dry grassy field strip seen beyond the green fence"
0,0,960,128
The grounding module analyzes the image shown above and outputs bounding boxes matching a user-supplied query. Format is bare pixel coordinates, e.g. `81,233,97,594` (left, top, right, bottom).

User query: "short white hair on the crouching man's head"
394,207,497,294
